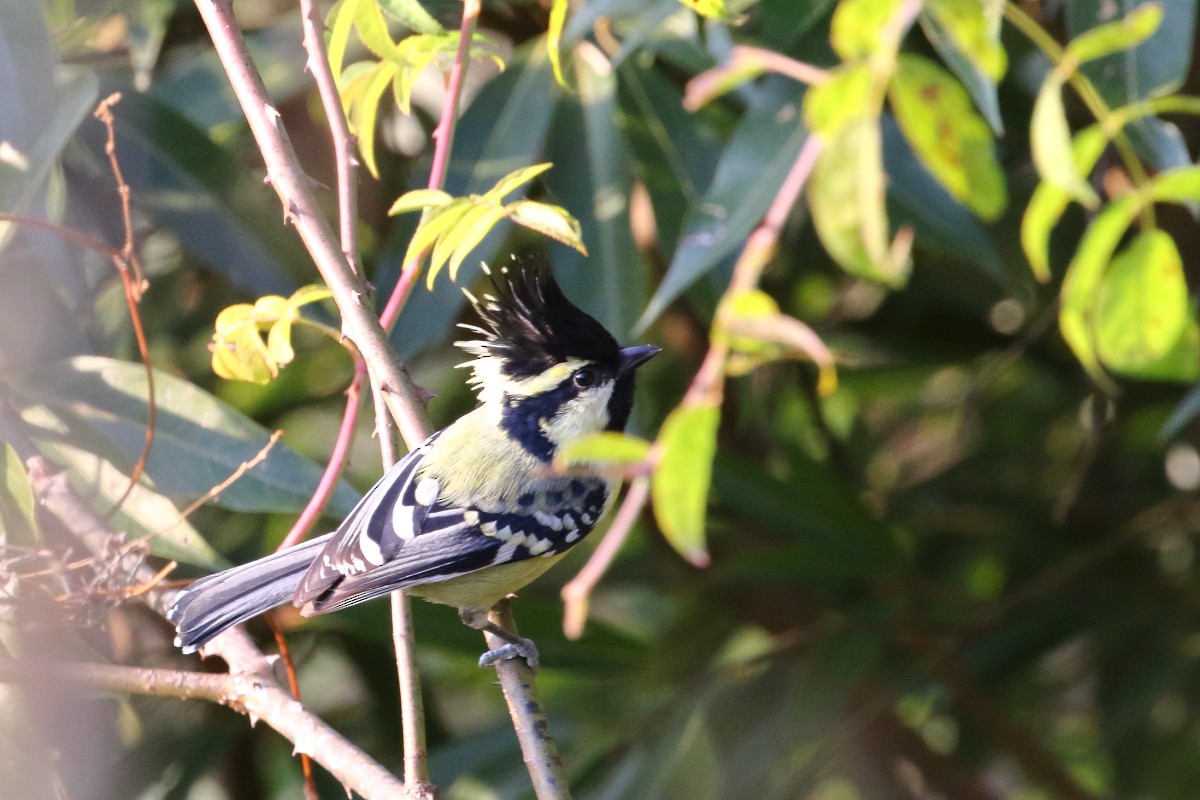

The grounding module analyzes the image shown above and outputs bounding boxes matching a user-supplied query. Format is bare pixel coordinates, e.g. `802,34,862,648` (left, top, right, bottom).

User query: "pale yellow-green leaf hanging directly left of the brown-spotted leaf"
809,112,910,287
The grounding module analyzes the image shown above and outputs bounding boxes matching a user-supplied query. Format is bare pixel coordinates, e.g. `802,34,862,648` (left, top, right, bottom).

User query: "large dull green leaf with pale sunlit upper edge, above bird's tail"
13,356,358,515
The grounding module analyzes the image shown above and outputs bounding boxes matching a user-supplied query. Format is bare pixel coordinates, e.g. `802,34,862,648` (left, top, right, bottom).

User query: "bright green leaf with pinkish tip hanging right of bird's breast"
650,404,721,566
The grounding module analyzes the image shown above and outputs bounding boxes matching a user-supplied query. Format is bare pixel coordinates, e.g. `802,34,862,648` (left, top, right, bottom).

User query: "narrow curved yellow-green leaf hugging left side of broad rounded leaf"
1058,194,1142,380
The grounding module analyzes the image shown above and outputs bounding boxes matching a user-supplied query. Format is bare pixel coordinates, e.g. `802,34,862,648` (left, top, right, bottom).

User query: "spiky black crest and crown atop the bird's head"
470,264,620,379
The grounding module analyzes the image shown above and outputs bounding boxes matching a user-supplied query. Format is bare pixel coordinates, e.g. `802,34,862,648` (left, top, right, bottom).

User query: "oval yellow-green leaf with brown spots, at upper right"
888,54,1008,219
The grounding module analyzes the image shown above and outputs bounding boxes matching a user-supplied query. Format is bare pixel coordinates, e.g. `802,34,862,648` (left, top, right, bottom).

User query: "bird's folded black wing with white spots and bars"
293,434,608,614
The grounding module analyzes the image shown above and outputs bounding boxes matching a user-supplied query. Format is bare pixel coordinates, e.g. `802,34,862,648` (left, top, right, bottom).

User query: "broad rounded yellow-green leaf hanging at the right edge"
1094,230,1200,380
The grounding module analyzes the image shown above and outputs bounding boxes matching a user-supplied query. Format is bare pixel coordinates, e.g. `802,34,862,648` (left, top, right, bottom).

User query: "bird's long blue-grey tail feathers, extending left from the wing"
167,534,332,652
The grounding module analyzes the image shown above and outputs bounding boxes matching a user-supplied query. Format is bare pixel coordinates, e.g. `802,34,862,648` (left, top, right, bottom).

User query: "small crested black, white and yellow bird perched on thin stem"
167,264,661,667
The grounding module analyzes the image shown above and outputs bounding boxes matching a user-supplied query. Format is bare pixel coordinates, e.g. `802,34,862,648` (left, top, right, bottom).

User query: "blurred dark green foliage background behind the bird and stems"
0,0,1200,800
